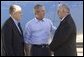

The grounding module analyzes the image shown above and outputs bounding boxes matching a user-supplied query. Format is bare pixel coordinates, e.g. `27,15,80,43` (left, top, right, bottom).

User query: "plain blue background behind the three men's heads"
1,1,83,33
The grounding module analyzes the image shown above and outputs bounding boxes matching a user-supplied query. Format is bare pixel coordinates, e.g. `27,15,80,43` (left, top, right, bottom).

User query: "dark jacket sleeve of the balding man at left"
2,25,14,56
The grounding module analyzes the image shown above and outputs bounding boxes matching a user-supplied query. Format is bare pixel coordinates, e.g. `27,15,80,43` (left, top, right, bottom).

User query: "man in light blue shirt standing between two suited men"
24,4,55,56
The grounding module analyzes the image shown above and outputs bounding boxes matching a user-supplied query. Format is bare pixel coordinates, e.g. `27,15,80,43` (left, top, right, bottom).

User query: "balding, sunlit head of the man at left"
9,5,22,20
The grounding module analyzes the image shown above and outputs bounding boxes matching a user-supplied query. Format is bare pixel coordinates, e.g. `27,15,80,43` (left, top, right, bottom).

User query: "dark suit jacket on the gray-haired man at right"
50,15,77,56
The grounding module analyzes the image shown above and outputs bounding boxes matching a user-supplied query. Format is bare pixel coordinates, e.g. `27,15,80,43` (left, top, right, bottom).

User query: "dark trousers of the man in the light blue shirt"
31,45,51,56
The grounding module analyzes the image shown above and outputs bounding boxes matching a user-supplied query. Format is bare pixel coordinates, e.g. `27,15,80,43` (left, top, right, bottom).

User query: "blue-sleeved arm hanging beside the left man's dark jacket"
24,24,31,56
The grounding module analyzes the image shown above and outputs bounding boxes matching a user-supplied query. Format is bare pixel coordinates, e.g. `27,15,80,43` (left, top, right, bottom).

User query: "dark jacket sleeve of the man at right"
50,24,72,51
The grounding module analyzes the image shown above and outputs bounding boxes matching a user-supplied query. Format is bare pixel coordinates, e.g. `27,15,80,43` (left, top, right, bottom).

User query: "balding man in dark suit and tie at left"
1,5,24,56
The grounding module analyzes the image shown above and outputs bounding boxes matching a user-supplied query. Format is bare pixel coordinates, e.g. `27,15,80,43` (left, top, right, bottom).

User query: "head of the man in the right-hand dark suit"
57,4,70,19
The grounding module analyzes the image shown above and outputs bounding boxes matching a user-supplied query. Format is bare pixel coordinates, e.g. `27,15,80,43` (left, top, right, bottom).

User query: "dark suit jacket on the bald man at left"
1,17,24,56
